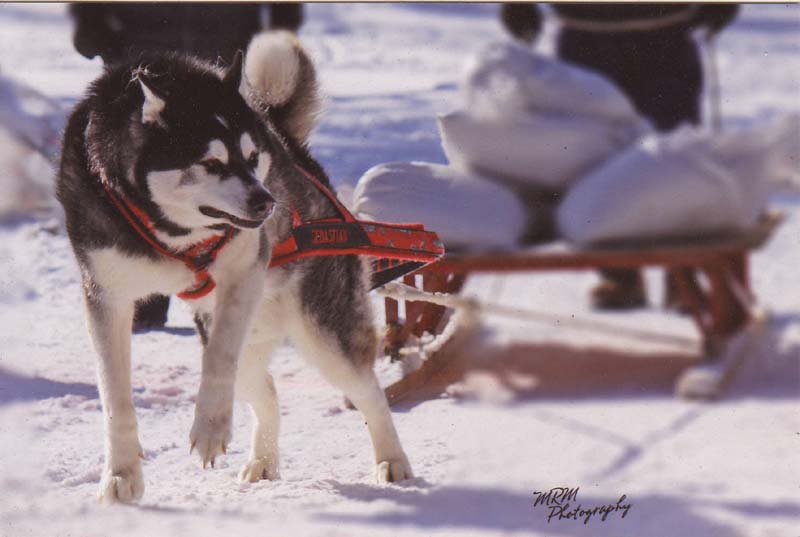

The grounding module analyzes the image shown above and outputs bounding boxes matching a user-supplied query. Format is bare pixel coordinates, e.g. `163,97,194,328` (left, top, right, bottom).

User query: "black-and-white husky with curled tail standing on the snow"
58,32,412,502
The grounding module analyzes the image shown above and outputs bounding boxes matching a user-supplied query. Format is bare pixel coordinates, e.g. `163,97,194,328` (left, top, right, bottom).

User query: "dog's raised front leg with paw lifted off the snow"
189,267,266,468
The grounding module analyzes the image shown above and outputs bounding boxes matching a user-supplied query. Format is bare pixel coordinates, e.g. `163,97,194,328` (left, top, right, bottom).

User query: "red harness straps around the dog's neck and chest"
103,181,239,300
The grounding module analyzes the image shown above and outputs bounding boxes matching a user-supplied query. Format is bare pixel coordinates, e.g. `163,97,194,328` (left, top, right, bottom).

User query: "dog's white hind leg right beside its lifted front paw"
236,340,280,482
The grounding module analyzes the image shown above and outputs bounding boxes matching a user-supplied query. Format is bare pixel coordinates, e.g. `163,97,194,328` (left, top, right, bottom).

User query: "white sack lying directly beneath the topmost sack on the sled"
439,111,642,190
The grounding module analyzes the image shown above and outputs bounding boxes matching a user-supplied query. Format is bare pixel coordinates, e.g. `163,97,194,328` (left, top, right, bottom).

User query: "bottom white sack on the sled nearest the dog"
353,162,528,250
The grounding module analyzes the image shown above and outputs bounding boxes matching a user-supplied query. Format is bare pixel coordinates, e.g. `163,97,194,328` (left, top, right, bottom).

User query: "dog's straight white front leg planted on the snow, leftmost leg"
85,280,144,503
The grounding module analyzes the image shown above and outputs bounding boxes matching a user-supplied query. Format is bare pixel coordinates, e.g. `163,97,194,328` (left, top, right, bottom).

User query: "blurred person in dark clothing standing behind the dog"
69,2,303,330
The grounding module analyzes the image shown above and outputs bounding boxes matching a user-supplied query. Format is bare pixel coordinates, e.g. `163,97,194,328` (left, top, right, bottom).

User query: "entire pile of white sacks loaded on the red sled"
354,43,800,249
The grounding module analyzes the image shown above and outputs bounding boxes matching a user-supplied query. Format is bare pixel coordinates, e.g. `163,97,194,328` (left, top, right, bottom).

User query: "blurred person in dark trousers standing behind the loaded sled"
500,3,739,309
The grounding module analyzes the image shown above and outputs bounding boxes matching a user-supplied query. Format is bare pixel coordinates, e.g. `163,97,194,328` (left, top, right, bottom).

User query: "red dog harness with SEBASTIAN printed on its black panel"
103,164,444,300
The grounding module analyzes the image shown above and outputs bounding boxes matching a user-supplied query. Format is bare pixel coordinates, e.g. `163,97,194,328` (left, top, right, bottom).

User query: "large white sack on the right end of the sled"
557,127,769,244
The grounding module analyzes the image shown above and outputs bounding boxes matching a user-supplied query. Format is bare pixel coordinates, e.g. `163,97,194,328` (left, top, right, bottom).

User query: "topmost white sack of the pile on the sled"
463,43,643,124
